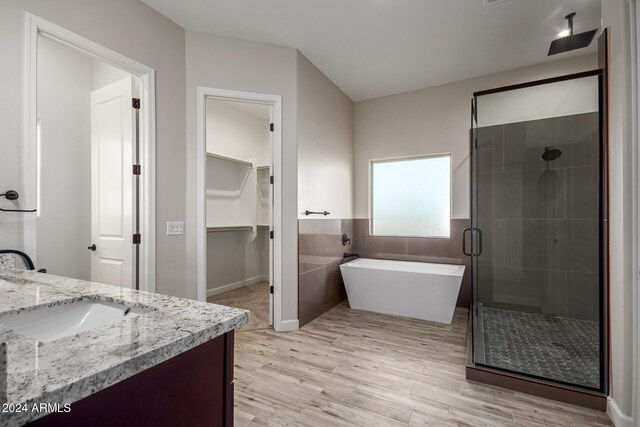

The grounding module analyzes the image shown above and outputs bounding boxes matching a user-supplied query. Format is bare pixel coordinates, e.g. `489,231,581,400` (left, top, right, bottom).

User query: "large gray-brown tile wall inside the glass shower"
477,113,599,320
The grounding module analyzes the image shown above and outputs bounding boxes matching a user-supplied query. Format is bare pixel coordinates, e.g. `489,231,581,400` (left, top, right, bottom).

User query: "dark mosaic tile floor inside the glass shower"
483,307,600,388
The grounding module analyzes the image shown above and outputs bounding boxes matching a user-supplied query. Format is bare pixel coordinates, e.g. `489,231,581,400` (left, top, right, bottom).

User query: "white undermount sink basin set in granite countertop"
0,299,148,342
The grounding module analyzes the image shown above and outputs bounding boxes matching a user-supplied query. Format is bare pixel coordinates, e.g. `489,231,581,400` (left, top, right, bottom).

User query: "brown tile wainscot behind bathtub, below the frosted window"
353,219,471,307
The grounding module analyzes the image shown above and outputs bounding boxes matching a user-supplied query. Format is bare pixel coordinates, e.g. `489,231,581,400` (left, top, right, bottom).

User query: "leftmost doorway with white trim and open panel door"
25,15,155,292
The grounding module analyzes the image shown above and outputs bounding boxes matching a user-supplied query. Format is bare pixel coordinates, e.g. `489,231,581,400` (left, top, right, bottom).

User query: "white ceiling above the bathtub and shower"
143,0,600,101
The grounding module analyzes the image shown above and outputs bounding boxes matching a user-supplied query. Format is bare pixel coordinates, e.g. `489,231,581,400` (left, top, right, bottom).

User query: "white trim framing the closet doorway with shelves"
196,86,284,331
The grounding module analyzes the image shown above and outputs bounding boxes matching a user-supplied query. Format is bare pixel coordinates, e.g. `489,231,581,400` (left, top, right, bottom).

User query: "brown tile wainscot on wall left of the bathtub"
298,219,353,327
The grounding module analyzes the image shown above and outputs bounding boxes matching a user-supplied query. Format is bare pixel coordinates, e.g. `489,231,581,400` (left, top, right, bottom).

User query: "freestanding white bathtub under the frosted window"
340,258,464,324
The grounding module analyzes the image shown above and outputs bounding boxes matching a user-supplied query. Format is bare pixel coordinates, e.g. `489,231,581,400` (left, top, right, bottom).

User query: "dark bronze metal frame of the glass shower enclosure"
464,29,609,411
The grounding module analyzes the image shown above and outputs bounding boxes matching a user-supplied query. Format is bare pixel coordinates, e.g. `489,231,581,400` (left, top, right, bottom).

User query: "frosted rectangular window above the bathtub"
370,154,451,237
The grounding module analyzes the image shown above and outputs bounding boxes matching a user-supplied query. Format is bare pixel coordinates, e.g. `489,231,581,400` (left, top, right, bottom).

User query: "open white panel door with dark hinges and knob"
89,77,136,288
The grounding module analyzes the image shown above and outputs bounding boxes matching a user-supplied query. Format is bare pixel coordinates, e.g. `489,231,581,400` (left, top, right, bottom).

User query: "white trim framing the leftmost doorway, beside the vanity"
24,12,156,292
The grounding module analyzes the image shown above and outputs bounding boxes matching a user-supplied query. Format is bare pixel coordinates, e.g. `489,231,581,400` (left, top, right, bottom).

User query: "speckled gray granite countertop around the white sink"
0,269,249,426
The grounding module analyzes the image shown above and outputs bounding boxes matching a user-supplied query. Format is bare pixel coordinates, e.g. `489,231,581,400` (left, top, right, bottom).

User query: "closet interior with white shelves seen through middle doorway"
199,88,279,330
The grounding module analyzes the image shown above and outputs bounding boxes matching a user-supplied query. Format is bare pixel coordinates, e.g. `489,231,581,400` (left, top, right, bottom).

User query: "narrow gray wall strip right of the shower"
602,0,640,416
